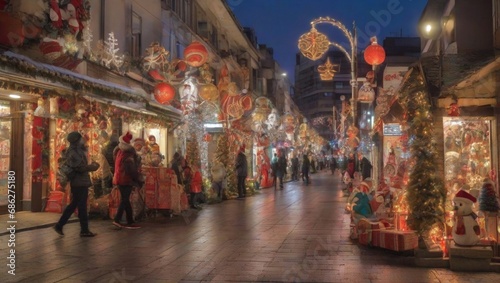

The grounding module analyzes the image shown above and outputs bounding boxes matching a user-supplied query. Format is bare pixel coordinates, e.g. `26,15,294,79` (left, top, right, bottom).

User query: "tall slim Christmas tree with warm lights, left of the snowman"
400,68,446,237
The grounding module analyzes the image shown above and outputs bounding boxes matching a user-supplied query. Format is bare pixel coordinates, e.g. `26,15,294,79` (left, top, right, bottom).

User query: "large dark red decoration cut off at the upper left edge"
0,12,25,47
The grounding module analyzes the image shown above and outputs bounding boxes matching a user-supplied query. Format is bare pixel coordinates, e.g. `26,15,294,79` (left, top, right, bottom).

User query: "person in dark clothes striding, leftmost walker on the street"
54,132,99,237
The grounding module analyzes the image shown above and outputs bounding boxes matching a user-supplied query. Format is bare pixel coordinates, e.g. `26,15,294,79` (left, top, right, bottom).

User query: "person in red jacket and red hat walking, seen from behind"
113,132,144,229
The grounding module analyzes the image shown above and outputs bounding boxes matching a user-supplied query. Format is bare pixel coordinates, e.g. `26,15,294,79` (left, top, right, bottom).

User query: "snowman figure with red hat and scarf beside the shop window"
452,190,480,246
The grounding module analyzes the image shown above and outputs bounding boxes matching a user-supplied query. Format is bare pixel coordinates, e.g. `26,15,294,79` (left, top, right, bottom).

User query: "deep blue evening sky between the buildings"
227,0,427,83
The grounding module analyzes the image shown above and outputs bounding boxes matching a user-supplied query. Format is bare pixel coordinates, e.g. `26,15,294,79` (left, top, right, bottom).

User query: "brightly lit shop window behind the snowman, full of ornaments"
443,117,493,195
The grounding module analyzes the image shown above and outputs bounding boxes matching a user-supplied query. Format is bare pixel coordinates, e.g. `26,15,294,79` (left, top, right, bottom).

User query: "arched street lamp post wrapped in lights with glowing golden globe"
299,17,358,126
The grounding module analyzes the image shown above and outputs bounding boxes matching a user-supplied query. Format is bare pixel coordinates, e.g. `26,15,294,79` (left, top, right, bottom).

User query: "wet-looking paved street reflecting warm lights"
0,172,500,283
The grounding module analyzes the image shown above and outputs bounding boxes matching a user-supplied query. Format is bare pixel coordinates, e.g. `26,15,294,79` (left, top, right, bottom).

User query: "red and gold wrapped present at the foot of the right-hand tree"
378,230,418,252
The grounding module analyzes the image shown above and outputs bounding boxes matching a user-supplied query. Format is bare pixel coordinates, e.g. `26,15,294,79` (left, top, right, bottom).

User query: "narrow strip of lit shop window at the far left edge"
0,100,11,206
